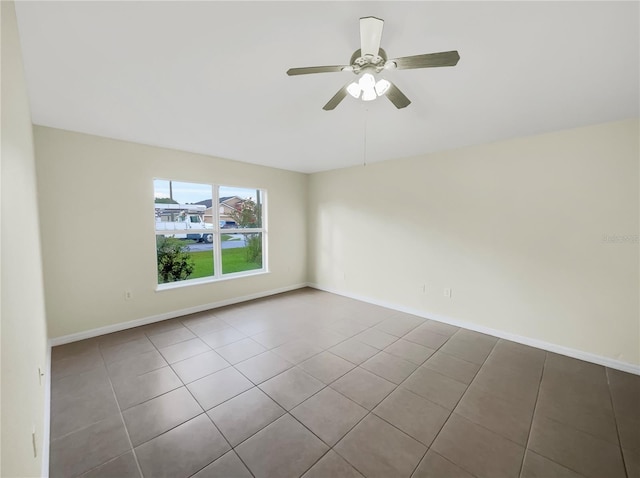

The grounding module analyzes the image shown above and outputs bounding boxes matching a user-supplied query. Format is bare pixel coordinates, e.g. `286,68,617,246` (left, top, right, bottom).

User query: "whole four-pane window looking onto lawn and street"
153,179,267,284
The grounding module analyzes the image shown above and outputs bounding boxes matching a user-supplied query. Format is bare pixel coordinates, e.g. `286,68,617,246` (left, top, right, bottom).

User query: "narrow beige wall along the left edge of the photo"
0,1,47,477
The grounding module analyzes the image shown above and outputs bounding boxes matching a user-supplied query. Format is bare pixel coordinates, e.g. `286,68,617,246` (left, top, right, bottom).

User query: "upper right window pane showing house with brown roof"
219,186,264,229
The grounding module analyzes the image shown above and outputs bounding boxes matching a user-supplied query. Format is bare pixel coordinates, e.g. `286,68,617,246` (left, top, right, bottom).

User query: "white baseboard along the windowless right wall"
307,282,640,375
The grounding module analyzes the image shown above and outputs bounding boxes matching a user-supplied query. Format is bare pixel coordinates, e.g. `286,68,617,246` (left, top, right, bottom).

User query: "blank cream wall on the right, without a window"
308,120,640,365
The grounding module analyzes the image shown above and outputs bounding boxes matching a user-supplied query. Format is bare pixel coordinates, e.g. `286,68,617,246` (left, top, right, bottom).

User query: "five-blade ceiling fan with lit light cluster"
287,17,460,111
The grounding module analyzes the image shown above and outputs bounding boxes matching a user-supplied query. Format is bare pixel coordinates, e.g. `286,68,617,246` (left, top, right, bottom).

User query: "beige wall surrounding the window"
35,126,307,338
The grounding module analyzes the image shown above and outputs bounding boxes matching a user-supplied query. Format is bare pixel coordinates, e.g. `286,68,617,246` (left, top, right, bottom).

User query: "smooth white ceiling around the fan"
16,1,640,172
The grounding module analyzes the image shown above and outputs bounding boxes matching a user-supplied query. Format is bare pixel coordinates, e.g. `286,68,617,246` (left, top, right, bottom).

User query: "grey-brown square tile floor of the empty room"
50,289,640,478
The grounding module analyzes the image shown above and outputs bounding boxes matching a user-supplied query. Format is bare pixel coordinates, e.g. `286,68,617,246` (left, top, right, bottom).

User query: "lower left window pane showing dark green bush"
156,235,214,284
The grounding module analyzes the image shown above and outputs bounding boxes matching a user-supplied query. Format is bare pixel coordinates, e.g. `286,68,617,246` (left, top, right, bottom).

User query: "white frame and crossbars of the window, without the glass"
153,178,269,291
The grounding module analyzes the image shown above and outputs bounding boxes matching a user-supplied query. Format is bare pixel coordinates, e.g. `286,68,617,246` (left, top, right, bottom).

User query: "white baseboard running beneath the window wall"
49,283,307,347
